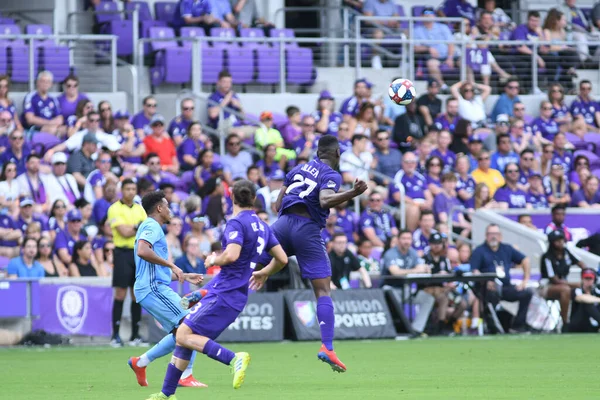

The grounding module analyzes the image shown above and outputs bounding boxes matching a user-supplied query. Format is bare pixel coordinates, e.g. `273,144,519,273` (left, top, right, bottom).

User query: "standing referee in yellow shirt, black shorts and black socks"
107,179,146,347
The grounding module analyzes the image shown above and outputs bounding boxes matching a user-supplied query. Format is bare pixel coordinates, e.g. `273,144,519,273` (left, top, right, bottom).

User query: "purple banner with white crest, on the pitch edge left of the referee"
33,285,113,336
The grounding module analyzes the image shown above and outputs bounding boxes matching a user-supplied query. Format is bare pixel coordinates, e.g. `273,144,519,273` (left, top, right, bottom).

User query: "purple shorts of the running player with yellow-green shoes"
183,294,240,340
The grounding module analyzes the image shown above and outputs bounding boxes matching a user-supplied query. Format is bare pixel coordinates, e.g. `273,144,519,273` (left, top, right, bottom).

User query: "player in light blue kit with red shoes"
128,191,206,387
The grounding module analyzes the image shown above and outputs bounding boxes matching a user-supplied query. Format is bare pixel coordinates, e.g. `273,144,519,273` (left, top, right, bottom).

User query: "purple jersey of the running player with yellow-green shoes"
208,210,279,311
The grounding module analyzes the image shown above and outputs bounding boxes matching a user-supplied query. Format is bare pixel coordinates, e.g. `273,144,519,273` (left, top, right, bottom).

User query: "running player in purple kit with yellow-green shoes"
148,180,287,400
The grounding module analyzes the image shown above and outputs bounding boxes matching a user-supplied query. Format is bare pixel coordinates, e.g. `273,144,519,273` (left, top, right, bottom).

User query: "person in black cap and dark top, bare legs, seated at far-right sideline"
540,231,585,326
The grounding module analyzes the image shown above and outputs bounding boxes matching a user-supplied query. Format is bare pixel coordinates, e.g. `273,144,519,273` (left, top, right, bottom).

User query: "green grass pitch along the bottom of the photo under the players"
0,335,600,400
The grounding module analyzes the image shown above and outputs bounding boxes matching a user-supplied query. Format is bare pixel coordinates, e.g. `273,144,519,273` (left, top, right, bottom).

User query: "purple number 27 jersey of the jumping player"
279,158,342,228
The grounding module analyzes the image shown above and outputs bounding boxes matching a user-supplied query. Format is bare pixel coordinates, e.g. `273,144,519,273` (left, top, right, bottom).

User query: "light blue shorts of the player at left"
140,284,189,333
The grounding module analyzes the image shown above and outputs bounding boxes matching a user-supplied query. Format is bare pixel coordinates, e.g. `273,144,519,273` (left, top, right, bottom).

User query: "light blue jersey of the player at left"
133,217,171,303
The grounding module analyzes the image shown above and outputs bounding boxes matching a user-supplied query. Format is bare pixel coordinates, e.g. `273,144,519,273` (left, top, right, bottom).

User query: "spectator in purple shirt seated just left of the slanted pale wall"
430,172,471,234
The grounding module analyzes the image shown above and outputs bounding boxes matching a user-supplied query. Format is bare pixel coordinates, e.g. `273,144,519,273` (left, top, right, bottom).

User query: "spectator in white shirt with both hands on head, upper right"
450,81,492,133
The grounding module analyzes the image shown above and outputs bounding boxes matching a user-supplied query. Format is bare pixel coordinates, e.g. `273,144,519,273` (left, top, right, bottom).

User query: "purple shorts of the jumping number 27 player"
270,214,331,279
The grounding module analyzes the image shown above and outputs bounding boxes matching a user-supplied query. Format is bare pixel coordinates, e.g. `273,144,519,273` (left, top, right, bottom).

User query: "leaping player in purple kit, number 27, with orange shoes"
251,135,368,372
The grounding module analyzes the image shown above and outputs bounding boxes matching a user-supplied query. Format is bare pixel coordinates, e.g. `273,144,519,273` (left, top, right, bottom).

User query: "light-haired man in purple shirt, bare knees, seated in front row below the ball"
389,152,433,230
